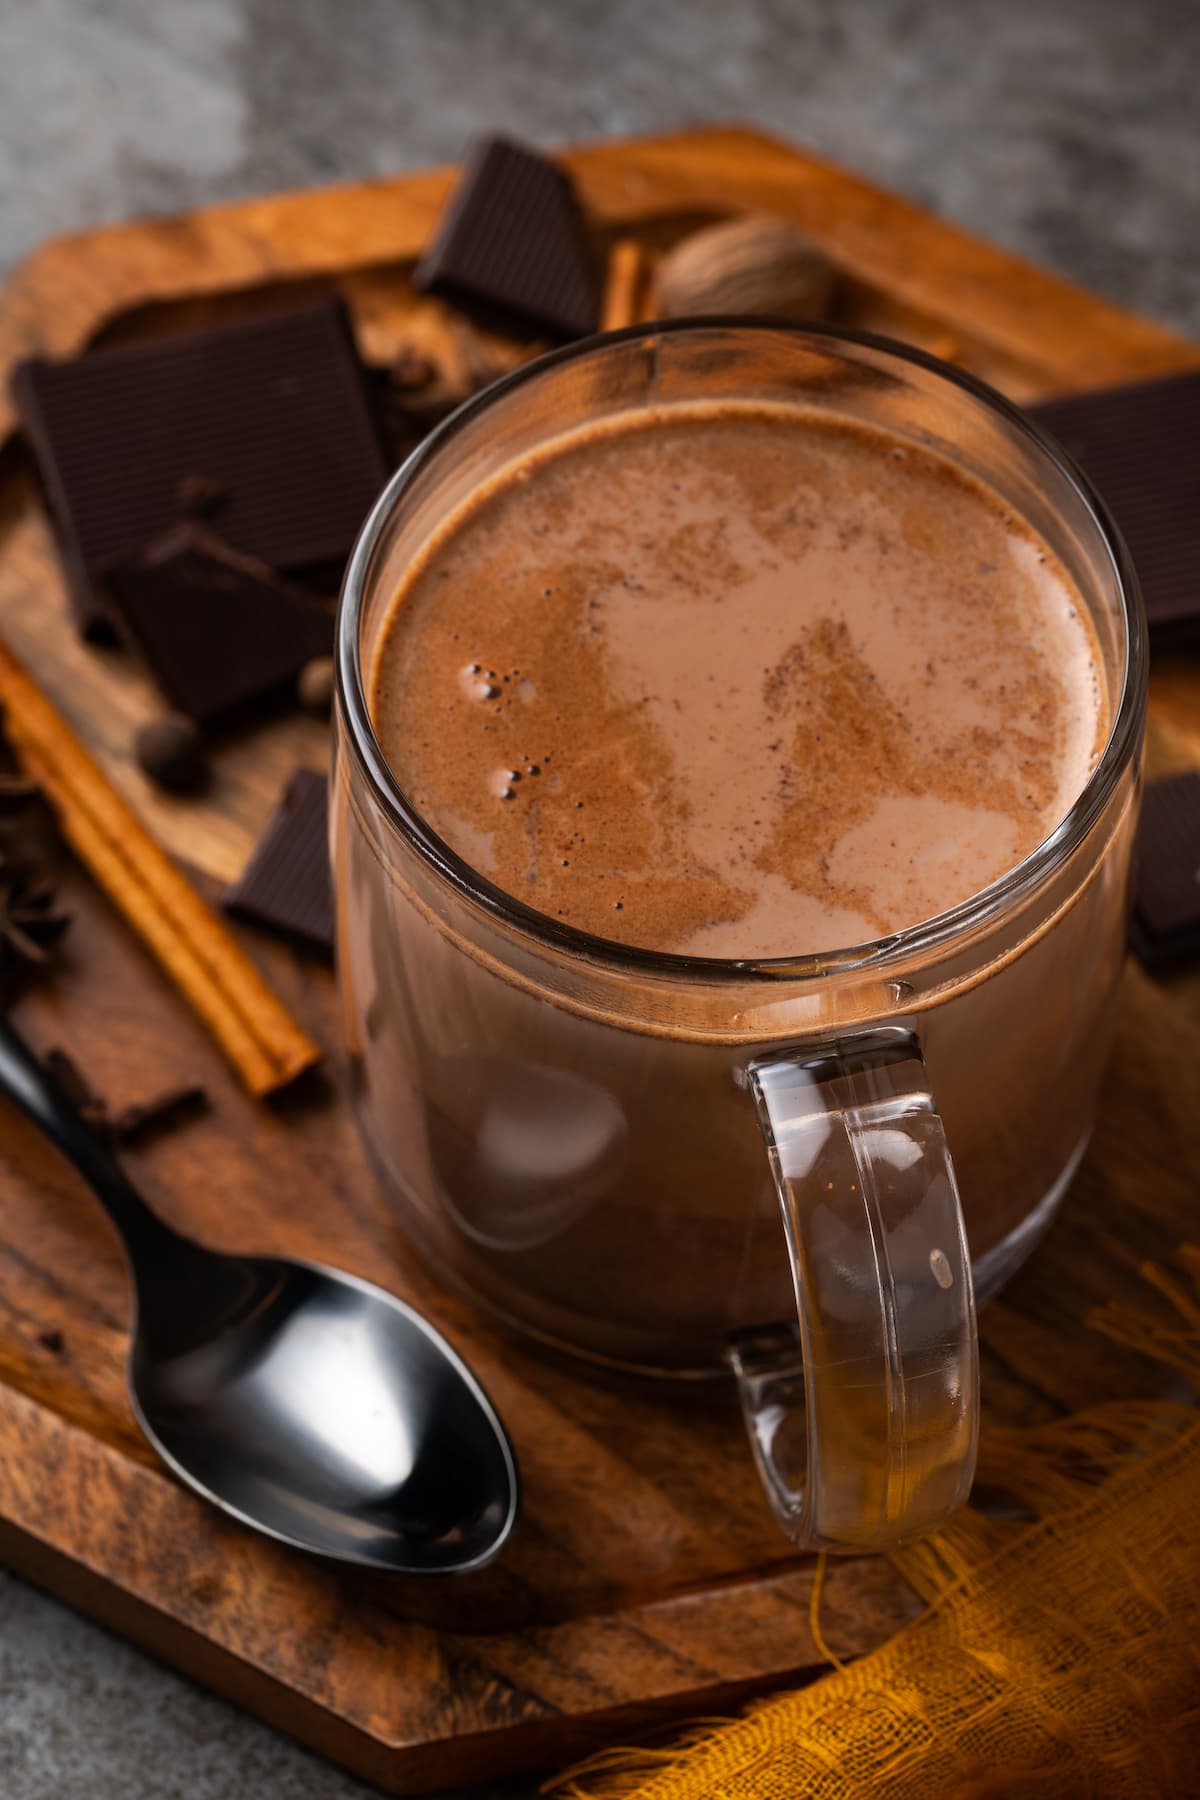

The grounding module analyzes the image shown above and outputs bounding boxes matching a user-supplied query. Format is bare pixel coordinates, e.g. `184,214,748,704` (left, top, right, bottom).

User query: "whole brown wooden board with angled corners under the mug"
0,130,1200,1793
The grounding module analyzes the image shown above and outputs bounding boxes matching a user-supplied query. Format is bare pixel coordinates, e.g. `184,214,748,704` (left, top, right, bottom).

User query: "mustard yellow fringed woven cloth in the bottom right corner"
554,1249,1200,1800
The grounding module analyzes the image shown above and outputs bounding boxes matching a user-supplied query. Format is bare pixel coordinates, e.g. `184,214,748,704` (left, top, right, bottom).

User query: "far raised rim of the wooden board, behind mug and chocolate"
0,124,1200,445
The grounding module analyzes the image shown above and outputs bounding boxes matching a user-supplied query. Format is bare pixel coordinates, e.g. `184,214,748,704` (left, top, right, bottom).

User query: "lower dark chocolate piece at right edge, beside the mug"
1130,770,1200,968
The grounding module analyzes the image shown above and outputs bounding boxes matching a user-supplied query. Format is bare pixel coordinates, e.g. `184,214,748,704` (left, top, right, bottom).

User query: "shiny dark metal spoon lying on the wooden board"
0,1019,518,1575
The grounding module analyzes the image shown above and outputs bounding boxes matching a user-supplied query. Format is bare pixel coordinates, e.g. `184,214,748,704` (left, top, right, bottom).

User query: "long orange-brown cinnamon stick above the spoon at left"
0,643,320,1094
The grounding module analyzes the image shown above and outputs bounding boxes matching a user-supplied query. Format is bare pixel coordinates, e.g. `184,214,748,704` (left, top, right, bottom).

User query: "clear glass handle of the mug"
729,1030,979,1552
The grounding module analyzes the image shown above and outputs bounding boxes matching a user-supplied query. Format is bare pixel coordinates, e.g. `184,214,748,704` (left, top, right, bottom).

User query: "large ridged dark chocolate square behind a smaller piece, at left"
13,299,389,635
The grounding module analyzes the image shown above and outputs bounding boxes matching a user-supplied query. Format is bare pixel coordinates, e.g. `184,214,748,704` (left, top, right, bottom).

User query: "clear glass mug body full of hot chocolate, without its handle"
333,343,1137,1372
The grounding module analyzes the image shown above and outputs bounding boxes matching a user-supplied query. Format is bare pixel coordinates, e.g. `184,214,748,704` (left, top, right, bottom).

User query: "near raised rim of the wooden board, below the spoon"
0,1388,907,1793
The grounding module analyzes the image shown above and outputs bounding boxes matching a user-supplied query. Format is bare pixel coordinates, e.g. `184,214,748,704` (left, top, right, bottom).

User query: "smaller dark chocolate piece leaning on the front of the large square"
104,524,333,724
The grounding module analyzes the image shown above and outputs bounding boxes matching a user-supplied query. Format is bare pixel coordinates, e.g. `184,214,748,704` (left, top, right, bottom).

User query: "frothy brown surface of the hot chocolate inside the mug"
372,403,1108,958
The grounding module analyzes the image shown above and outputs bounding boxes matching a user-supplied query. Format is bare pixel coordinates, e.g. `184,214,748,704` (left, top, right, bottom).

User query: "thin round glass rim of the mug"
335,313,1148,983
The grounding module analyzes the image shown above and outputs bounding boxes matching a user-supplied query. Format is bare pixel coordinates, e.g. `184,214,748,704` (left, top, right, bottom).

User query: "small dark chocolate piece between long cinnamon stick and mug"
225,769,333,952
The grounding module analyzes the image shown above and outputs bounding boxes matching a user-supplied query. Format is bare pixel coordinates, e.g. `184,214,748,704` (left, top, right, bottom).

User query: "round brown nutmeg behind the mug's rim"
657,212,837,319
